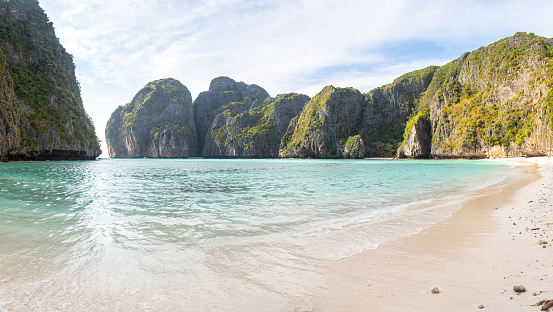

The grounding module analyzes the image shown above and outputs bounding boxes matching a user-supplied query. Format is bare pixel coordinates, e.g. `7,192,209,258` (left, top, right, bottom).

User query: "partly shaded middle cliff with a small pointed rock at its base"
280,66,437,158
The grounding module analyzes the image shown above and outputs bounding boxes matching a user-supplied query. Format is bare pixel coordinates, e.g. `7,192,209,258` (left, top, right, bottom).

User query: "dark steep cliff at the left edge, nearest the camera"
0,0,101,160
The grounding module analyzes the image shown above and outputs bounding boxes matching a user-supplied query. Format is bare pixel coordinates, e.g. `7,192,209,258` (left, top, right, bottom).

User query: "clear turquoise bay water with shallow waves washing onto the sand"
0,159,515,311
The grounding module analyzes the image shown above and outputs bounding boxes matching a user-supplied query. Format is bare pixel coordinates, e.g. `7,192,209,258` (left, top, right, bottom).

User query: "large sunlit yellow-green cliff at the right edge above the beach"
404,33,553,158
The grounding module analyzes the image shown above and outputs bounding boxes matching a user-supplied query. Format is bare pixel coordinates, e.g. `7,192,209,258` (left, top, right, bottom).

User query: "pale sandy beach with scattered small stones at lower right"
291,158,553,312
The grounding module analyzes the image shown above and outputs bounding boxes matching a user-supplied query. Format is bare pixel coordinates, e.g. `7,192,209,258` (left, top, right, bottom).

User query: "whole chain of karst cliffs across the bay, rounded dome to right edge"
106,32,553,158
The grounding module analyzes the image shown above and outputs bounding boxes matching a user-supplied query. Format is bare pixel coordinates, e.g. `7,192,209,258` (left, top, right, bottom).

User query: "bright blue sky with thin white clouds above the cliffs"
39,0,553,157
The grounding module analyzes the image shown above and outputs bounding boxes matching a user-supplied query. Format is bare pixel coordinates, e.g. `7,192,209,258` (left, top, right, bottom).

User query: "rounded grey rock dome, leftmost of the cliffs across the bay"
106,79,198,158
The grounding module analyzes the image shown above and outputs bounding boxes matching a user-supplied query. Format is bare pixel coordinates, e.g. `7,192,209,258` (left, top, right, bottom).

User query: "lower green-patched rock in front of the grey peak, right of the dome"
203,93,309,158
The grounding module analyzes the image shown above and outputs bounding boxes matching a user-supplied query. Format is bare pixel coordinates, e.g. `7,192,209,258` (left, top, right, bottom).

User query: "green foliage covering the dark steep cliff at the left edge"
0,0,100,151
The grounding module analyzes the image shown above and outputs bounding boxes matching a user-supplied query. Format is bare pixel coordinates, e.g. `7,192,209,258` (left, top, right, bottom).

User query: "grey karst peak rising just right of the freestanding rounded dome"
194,77,269,157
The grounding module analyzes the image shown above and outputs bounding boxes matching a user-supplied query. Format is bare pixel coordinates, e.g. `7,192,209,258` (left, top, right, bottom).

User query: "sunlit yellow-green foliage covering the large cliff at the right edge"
394,33,553,153
